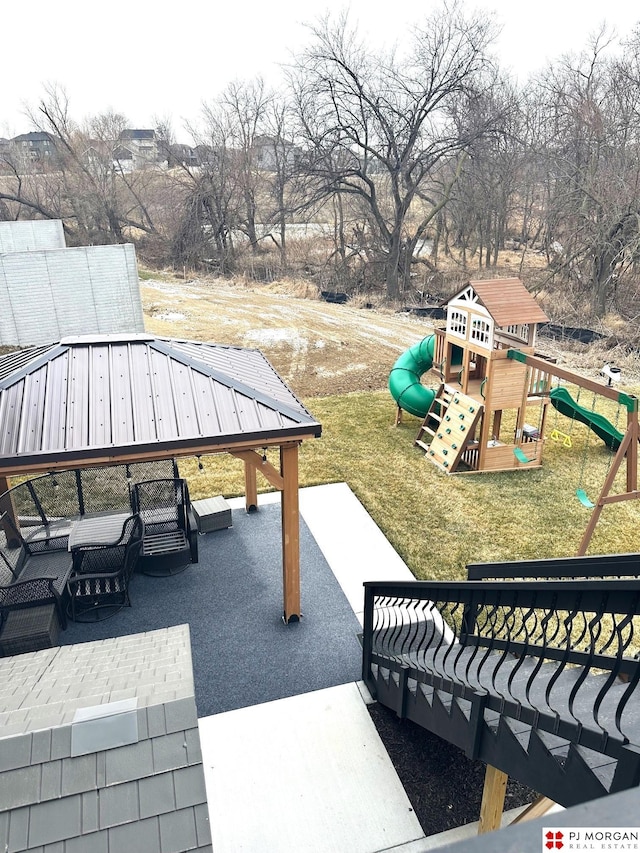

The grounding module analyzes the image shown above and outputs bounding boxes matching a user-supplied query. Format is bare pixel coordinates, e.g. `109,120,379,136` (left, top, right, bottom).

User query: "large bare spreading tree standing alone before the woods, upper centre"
291,3,500,299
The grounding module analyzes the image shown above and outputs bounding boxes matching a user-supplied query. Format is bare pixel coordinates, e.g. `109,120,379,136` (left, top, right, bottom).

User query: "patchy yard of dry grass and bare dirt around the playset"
143,272,640,579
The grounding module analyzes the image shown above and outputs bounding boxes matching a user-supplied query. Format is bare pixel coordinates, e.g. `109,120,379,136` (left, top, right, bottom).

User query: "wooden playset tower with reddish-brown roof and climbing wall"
416,278,550,473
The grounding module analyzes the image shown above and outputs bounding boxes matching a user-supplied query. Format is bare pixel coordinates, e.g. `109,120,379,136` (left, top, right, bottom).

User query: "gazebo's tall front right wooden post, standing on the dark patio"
280,444,302,622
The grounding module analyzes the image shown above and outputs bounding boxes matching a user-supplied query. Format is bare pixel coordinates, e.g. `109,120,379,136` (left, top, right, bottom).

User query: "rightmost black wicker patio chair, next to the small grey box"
133,478,198,576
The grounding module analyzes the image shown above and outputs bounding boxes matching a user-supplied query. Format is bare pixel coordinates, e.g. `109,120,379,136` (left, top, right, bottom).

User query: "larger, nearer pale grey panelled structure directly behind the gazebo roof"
0,244,144,346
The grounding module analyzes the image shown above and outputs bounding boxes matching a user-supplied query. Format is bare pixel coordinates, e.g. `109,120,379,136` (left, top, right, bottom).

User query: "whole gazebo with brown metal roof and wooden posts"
0,334,322,622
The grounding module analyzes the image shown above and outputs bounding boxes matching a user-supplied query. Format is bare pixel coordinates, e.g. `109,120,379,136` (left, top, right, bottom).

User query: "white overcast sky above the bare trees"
0,0,640,141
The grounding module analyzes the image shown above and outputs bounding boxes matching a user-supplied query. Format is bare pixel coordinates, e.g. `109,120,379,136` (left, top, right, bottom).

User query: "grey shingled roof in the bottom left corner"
0,625,211,853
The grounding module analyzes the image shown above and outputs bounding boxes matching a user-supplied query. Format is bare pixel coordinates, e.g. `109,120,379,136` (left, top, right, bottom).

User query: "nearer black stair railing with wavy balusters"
363,579,640,759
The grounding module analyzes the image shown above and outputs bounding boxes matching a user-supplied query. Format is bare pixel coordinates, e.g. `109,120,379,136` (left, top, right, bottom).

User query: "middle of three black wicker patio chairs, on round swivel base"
67,515,144,622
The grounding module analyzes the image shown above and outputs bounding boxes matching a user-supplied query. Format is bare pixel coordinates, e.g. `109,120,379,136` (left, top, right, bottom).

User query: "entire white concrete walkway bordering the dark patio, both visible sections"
199,483,544,853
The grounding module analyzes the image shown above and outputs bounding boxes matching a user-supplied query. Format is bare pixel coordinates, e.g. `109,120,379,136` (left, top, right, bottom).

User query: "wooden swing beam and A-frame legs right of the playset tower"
507,350,640,557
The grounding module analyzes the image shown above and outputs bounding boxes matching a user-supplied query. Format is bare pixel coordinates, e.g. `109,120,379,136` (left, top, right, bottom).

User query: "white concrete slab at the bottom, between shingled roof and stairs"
200,684,423,853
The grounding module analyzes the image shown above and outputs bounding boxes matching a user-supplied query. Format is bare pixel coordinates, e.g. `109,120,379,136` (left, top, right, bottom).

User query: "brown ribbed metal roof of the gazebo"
0,335,321,469
